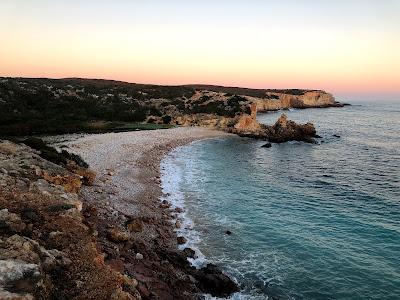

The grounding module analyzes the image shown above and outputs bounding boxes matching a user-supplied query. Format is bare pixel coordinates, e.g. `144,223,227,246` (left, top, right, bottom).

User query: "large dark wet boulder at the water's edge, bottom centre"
194,264,239,297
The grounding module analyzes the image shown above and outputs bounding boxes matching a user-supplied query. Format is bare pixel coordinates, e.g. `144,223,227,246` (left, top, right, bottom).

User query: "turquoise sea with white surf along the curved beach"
163,105,400,300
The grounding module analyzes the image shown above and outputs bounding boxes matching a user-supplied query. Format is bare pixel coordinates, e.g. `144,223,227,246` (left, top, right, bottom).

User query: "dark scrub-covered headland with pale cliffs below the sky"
0,78,339,135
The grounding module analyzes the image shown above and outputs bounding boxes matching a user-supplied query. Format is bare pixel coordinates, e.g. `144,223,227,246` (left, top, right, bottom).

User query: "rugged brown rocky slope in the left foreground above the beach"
0,141,141,300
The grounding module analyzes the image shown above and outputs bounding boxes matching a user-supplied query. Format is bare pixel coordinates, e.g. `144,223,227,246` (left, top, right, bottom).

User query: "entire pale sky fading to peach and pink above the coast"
0,0,400,101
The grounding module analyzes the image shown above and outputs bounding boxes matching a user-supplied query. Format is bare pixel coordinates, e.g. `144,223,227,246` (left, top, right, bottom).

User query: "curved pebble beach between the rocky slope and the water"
58,127,238,299
